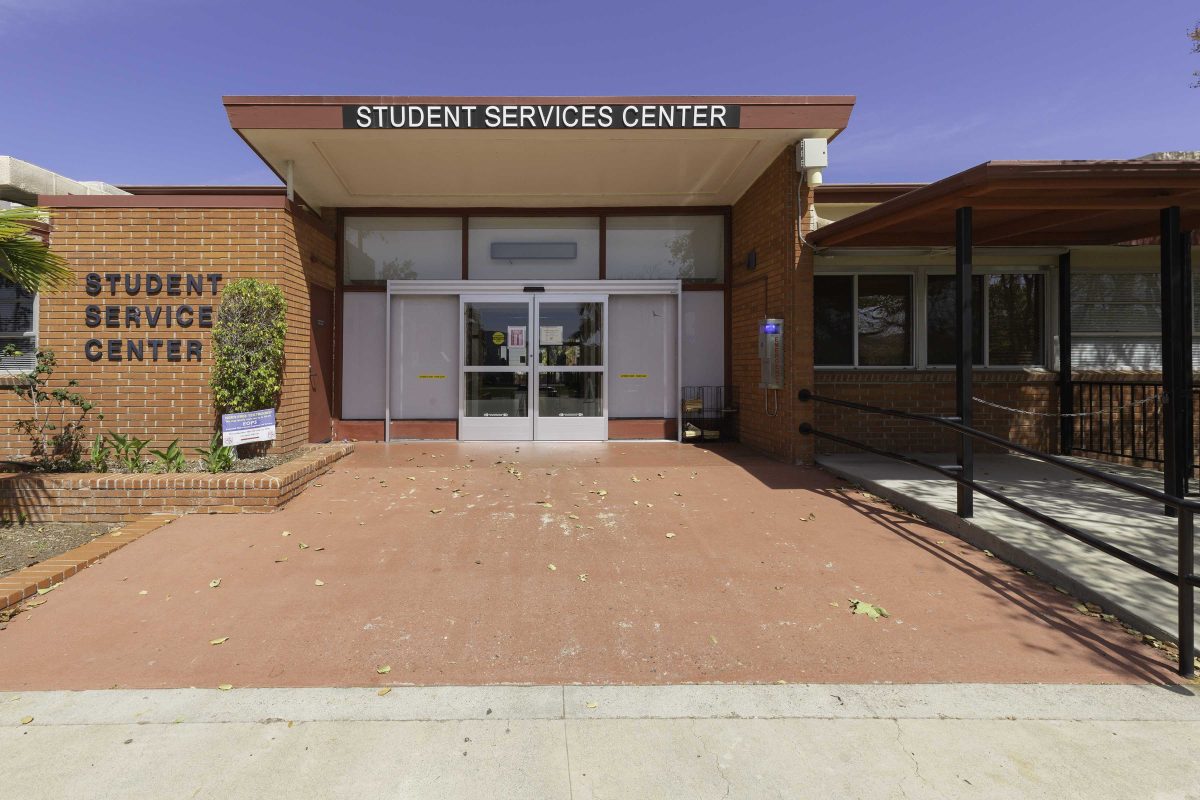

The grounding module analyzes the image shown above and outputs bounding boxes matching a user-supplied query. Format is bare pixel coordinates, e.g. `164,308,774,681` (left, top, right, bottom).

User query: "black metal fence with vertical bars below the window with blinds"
1063,380,1200,477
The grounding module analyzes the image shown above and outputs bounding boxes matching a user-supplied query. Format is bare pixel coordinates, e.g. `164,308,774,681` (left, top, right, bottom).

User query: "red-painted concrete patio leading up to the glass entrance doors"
0,443,1174,690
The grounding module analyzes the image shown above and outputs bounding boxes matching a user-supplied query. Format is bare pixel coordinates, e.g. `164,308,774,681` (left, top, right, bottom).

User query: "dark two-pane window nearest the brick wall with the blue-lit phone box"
814,275,913,367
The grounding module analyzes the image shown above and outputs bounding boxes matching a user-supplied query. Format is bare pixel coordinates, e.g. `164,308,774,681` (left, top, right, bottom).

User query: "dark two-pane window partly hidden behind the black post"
925,272,1045,367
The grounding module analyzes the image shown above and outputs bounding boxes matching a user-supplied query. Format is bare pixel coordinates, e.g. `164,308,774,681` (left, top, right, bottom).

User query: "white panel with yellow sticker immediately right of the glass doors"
608,295,678,419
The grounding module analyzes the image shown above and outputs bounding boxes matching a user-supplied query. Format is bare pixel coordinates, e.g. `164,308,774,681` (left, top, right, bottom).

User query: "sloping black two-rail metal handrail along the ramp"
799,389,1200,678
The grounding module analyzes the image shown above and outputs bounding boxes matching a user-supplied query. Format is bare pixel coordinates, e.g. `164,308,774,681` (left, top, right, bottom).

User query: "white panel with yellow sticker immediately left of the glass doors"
391,295,460,420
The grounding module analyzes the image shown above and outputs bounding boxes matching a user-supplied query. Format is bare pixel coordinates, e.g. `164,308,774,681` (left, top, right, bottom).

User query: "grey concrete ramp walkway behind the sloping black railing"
817,453,1200,642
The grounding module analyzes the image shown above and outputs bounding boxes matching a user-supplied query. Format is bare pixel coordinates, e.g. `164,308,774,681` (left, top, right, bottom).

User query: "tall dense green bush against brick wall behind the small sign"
209,278,288,414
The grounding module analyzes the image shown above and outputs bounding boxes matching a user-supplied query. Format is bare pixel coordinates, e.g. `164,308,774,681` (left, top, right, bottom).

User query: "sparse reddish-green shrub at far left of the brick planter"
2,344,104,470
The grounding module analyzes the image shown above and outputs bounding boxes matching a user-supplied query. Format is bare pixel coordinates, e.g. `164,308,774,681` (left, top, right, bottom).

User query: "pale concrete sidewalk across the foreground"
0,684,1200,800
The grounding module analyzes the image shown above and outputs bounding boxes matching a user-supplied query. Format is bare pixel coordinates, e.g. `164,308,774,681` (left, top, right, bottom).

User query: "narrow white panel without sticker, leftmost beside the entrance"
342,291,388,420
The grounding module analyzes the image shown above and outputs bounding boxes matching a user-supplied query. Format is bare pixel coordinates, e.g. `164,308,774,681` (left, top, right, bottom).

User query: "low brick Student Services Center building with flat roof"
0,96,1200,470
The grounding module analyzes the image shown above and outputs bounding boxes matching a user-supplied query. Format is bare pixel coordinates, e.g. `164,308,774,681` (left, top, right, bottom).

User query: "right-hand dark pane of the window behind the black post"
988,275,1045,367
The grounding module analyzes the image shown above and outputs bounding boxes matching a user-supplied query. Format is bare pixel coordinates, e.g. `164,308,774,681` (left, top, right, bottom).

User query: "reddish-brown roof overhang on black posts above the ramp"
808,161,1200,247
